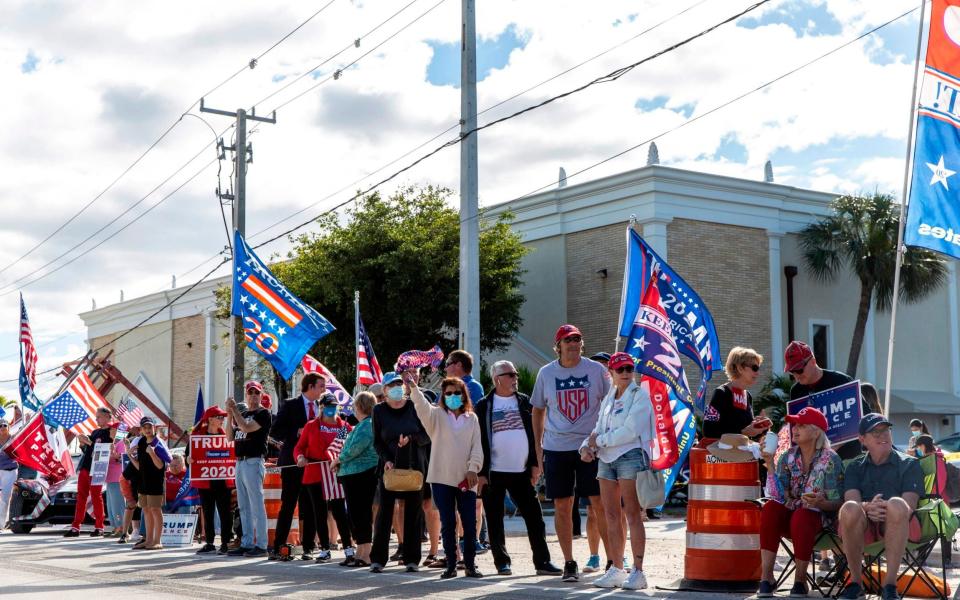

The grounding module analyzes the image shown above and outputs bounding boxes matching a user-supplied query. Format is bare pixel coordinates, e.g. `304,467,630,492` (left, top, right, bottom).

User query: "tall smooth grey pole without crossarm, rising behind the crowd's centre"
460,0,480,364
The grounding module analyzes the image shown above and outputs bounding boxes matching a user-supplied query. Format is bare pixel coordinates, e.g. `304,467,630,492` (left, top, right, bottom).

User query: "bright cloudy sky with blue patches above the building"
0,0,919,404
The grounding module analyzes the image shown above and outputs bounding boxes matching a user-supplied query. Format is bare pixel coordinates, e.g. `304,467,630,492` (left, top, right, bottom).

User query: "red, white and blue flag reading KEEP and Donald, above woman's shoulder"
624,270,696,500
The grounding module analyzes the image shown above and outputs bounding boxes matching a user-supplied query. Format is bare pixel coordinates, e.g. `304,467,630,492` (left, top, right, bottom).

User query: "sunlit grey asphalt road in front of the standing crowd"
0,519,957,600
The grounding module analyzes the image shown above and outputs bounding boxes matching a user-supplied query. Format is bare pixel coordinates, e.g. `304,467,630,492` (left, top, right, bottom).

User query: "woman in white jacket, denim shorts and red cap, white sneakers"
580,352,656,590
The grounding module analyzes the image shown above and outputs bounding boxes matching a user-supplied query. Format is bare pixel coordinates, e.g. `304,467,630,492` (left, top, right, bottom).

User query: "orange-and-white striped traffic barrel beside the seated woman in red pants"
680,447,760,592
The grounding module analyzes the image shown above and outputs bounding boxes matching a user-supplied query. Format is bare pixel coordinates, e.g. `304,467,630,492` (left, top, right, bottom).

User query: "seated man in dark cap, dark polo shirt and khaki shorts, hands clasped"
840,413,923,600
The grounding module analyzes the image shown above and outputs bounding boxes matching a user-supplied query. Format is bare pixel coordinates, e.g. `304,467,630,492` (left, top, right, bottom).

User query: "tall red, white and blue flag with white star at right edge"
903,0,960,258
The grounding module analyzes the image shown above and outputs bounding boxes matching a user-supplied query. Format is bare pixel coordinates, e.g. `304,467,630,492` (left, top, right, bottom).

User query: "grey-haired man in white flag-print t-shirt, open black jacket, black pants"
474,360,561,575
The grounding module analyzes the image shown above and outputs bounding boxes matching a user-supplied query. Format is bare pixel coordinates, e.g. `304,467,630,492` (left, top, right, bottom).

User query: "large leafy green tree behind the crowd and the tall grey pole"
226,187,527,387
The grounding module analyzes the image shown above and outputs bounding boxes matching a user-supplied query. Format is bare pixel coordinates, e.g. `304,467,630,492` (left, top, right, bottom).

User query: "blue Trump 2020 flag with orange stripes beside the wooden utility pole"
230,231,334,379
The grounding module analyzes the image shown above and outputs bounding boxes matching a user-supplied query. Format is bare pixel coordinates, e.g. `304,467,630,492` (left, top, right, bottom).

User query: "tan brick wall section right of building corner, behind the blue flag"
668,219,771,392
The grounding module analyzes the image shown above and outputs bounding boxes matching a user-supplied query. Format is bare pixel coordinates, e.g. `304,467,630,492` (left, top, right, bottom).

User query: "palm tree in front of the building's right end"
800,193,947,377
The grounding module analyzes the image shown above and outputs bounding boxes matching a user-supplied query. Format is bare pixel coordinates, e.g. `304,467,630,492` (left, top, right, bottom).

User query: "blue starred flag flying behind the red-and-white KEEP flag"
619,227,723,413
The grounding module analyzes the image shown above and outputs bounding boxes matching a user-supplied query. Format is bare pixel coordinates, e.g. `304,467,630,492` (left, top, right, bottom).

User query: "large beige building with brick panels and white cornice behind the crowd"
80,165,960,441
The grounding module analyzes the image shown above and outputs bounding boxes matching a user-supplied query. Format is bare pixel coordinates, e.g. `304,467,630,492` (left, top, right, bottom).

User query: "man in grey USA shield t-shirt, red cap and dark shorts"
530,325,610,582
